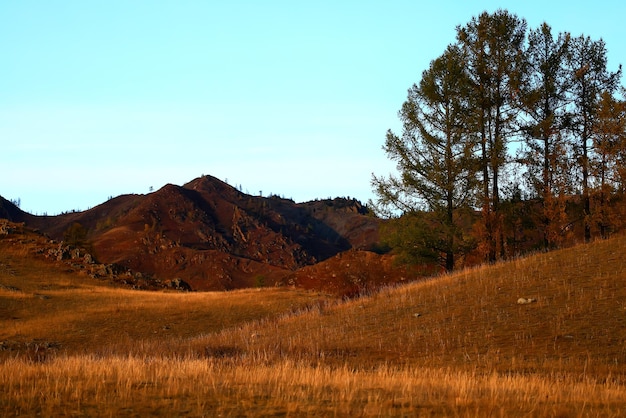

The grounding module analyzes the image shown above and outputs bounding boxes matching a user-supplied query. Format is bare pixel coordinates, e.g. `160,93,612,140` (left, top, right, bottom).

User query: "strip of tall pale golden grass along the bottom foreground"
0,356,626,417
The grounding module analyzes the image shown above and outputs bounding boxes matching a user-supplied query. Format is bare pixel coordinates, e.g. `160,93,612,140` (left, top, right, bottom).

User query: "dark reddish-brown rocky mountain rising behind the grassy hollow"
0,176,390,290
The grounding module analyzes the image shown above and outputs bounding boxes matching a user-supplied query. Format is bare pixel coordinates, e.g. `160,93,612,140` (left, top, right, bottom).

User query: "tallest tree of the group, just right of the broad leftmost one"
457,10,526,261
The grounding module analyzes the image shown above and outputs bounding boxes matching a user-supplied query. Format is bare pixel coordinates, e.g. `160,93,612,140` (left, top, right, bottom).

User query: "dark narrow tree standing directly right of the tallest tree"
519,23,570,249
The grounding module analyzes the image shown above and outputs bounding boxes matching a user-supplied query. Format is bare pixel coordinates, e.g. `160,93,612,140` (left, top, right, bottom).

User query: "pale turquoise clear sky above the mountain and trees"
0,0,626,215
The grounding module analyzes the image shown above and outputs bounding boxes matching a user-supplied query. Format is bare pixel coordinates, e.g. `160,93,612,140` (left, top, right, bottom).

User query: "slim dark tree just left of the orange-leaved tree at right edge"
568,36,621,242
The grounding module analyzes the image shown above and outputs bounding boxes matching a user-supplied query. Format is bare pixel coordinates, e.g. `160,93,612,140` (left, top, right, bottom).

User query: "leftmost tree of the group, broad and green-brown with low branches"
372,46,475,271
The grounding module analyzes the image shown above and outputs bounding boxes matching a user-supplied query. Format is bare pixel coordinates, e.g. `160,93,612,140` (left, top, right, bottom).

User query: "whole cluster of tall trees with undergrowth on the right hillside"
370,10,626,270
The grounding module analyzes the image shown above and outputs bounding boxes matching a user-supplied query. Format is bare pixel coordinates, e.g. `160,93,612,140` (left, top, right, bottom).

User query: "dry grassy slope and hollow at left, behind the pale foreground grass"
0,233,329,358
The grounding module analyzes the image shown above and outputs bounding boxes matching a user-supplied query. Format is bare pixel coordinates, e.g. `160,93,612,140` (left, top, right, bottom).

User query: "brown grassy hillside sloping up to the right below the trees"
197,232,626,379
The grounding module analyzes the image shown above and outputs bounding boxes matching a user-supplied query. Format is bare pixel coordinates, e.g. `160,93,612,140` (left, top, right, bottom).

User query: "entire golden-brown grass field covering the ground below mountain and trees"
0,227,626,417
